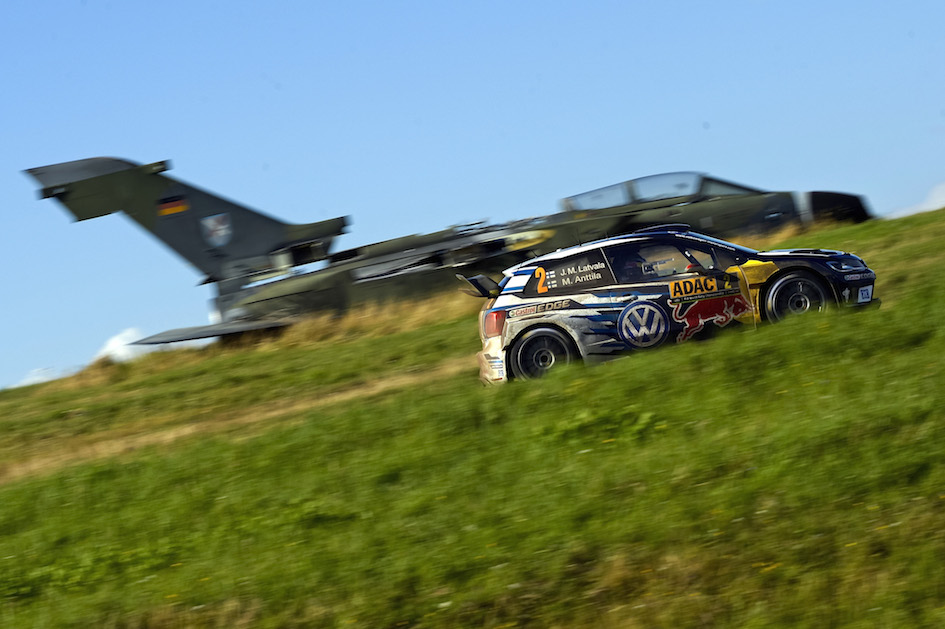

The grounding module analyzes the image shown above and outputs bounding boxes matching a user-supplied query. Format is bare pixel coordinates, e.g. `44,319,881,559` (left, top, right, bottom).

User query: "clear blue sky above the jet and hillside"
0,0,945,387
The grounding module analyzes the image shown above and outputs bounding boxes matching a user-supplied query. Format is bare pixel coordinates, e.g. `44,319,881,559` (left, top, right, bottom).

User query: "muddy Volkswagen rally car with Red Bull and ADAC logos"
460,225,879,383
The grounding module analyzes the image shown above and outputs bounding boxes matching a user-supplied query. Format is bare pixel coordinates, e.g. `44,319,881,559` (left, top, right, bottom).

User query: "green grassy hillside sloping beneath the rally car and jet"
0,211,945,628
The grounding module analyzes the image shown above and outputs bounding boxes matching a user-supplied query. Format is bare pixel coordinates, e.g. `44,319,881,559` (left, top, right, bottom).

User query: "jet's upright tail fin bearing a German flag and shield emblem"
26,157,347,290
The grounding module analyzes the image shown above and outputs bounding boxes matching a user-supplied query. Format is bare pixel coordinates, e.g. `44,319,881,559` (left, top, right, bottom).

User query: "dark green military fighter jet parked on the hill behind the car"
25,157,869,344
